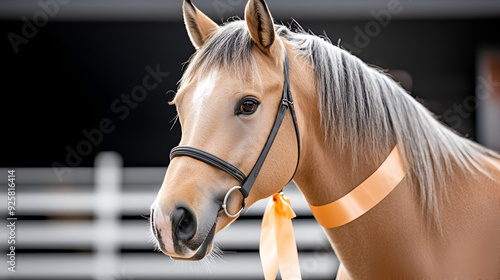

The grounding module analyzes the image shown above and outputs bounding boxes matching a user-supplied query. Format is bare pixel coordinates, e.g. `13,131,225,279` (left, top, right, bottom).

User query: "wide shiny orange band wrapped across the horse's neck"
309,145,406,228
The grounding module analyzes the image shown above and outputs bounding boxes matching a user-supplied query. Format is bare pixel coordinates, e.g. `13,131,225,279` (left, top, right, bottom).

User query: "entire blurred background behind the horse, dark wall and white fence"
0,0,500,280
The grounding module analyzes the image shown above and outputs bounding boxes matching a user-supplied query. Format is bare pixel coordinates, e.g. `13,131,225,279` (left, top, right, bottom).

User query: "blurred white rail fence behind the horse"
0,153,338,280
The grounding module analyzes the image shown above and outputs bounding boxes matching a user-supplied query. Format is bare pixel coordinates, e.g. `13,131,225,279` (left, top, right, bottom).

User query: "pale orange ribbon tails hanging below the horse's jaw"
259,193,302,280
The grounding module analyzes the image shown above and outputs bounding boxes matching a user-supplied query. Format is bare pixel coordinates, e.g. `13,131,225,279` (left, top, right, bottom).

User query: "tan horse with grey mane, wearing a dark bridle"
151,0,500,279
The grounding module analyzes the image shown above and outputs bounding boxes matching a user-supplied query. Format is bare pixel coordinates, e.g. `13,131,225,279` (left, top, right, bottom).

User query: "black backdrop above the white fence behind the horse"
0,6,500,167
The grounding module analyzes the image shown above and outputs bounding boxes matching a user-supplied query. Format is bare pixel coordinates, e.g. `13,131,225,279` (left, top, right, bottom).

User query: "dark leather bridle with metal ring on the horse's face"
170,49,300,218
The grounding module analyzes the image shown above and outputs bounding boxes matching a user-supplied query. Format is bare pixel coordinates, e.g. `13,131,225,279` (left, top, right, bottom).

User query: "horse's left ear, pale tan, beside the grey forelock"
182,0,219,49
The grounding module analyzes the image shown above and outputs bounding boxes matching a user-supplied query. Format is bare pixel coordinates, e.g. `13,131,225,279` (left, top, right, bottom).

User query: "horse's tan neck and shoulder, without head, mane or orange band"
285,44,500,279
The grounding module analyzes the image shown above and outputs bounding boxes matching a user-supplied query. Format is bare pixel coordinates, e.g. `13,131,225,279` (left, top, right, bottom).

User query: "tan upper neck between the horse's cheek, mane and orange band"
290,50,395,205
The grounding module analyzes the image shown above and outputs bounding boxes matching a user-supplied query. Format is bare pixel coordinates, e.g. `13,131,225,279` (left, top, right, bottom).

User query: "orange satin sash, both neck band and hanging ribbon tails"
259,145,406,280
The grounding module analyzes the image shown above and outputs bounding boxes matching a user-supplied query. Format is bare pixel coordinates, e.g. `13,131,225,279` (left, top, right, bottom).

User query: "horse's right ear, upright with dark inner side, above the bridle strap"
245,0,276,52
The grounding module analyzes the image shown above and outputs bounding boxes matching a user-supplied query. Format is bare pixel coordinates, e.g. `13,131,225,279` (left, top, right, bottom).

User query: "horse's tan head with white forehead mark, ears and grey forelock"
151,0,298,260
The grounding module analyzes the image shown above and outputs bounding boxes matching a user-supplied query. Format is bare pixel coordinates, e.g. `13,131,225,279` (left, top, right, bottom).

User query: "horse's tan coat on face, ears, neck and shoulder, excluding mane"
152,0,500,280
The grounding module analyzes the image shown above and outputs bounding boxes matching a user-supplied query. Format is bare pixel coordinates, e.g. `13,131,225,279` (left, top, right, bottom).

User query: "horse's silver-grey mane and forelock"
181,21,500,228
